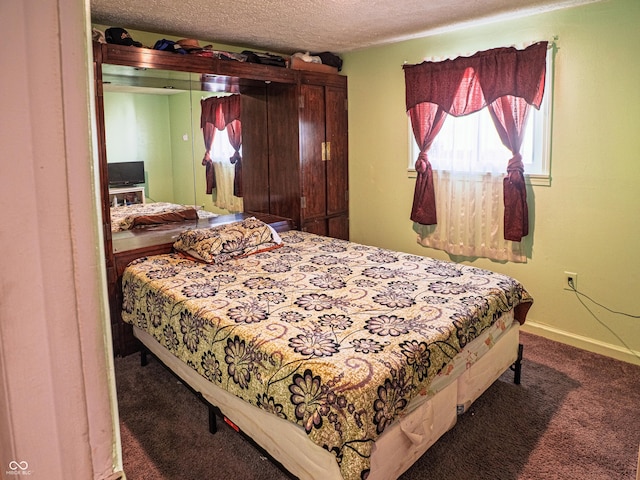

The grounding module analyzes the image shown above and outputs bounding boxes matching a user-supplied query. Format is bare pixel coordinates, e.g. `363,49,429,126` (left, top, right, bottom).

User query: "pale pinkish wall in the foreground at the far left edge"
0,0,122,480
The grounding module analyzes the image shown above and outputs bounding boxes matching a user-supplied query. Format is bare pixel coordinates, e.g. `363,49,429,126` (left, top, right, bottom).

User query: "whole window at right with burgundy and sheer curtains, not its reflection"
403,41,552,262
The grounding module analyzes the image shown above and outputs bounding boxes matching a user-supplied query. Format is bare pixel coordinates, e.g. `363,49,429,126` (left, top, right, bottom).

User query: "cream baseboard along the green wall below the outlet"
522,320,640,365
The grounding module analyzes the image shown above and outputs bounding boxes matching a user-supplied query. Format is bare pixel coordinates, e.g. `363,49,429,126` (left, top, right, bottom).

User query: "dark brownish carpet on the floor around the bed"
115,333,640,480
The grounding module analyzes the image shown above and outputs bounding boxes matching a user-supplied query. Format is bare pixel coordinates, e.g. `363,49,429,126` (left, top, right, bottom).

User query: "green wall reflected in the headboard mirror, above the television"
104,91,229,214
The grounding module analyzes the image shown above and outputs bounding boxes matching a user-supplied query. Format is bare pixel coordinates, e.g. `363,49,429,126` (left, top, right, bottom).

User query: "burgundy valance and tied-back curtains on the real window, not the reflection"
403,42,547,241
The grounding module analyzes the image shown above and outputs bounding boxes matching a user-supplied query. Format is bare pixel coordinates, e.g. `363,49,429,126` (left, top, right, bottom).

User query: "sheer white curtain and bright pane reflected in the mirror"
210,130,244,213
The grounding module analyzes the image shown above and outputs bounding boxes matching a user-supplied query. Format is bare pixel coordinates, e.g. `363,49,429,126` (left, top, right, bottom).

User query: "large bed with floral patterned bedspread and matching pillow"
122,219,533,480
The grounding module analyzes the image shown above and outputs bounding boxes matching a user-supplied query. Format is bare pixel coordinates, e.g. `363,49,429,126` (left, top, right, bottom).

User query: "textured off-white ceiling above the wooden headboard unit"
91,0,597,53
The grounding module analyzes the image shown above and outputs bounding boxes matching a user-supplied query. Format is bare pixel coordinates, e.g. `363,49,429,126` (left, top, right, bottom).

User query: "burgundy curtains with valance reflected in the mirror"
200,95,242,197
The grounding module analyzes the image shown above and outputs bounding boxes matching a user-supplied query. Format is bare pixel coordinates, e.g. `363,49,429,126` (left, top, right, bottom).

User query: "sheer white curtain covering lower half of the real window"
418,170,526,263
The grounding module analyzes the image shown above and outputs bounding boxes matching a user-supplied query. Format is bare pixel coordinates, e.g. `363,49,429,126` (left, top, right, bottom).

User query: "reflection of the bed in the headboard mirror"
111,202,216,232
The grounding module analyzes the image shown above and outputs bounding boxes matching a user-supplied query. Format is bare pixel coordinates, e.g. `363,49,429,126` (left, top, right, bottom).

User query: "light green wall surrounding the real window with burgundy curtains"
343,0,640,363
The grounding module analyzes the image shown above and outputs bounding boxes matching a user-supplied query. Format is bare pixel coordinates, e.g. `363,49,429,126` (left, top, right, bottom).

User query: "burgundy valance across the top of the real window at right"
403,42,547,116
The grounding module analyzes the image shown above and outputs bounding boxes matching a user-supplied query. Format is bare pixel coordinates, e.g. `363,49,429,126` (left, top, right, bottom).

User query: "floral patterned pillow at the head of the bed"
173,217,282,263
